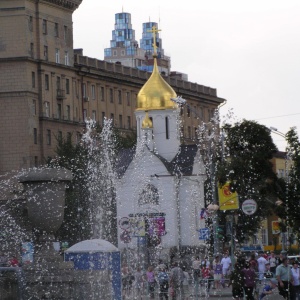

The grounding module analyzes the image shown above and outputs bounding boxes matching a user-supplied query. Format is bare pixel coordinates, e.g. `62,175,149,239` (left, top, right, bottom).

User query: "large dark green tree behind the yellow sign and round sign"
218,120,281,244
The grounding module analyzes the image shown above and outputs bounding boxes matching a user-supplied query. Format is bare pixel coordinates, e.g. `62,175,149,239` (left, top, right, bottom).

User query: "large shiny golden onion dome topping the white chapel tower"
136,57,177,110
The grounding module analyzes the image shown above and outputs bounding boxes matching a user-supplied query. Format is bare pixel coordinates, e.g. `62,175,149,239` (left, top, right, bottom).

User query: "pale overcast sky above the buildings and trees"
73,0,300,151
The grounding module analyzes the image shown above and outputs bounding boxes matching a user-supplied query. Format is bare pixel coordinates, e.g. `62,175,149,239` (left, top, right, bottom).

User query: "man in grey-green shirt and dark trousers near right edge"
276,257,293,300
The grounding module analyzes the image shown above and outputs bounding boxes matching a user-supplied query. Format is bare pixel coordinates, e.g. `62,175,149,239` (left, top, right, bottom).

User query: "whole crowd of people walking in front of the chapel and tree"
122,252,300,300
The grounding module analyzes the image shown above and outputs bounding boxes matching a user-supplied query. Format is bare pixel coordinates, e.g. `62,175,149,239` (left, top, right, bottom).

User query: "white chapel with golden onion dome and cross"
117,29,205,261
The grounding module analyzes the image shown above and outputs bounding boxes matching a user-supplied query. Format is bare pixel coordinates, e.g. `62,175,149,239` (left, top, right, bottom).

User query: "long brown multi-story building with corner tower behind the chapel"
0,0,224,174
